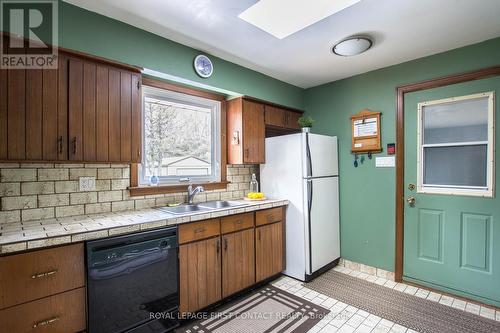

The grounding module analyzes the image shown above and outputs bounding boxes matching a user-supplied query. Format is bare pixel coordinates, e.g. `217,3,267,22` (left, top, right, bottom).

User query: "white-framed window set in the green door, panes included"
417,92,494,197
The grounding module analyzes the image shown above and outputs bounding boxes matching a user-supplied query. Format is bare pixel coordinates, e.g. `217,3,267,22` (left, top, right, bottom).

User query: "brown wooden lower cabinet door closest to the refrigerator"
255,222,284,282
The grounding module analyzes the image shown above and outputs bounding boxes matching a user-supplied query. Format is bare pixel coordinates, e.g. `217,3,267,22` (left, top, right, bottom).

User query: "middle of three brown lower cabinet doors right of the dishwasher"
222,228,255,297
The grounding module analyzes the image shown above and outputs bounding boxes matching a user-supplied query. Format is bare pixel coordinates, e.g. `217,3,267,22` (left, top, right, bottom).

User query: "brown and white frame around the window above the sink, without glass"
137,78,222,185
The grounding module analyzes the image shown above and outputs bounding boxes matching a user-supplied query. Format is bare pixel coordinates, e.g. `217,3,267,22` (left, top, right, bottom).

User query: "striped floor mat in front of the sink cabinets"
176,285,330,333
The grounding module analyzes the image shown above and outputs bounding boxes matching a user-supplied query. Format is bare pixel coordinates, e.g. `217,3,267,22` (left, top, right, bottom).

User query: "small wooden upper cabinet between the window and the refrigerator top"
227,98,265,164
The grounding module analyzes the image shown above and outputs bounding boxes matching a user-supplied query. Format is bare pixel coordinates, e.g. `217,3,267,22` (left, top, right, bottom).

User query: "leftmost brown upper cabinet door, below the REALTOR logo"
0,59,67,161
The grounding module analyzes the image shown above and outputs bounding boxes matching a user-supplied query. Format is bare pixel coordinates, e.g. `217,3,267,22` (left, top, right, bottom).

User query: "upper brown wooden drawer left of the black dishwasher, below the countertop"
0,243,85,309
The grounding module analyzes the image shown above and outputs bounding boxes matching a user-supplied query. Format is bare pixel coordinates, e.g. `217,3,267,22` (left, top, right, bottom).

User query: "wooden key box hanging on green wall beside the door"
351,109,382,153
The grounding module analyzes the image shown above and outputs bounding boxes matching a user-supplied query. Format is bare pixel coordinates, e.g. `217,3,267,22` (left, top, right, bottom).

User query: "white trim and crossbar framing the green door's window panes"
417,91,495,198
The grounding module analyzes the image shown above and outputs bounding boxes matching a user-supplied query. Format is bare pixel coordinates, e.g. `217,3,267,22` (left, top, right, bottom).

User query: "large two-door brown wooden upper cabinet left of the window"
0,52,141,163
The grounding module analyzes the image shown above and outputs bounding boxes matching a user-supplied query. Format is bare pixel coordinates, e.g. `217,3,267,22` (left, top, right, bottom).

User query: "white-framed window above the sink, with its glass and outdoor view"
139,86,221,185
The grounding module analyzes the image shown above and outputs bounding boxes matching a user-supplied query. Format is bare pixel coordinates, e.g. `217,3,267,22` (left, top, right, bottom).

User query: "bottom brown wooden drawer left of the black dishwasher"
0,288,85,333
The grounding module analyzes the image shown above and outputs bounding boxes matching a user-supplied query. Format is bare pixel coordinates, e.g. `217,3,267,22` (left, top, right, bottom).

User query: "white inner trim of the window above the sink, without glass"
138,86,222,186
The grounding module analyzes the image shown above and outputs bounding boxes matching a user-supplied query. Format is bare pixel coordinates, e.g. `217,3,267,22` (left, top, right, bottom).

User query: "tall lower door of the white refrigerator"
303,177,340,275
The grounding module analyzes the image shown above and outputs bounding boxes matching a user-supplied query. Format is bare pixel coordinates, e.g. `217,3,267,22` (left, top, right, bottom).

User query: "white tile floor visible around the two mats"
272,266,500,333
